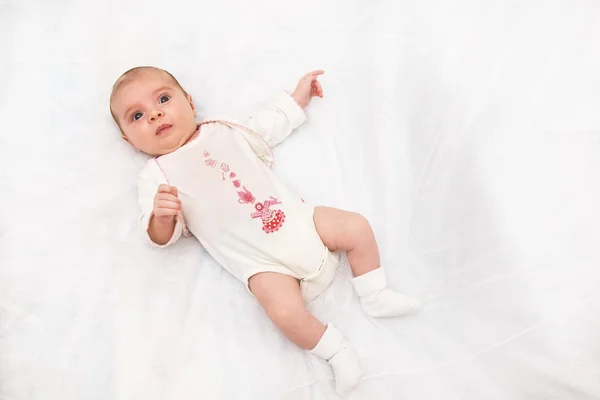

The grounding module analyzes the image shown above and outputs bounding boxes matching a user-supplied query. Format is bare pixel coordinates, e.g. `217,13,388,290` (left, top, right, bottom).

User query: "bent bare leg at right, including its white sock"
314,207,420,317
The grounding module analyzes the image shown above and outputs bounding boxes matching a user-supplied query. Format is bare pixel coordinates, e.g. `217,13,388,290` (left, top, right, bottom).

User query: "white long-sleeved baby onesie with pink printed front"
138,94,339,301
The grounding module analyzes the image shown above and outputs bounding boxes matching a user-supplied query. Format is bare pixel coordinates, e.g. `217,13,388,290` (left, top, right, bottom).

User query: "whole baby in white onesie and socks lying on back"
110,67,419,395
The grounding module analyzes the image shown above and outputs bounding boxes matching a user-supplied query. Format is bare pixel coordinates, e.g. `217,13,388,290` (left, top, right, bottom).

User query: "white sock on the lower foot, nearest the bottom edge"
310,324,362,396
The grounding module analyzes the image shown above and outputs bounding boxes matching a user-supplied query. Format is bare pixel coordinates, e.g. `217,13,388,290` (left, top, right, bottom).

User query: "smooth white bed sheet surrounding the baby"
0,0,600,400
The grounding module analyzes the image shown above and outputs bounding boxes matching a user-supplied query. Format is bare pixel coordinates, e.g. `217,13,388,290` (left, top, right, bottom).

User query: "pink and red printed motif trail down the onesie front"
203,151,285,233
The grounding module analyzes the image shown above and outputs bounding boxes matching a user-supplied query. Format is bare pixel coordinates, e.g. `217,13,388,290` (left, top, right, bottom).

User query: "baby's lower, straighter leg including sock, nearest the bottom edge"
248,272,362,396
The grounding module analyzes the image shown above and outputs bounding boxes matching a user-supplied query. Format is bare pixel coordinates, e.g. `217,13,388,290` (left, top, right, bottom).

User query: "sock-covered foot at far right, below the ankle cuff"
360,289,421,317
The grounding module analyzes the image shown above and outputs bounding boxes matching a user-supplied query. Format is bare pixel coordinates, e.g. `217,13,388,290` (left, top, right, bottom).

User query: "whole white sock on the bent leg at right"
352,268,421,317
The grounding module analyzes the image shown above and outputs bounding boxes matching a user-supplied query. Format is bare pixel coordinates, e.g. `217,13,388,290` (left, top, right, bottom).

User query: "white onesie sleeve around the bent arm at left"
137,160,183,248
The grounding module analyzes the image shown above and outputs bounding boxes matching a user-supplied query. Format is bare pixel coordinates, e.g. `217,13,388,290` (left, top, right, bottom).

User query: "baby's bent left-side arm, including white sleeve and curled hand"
138,162,183,247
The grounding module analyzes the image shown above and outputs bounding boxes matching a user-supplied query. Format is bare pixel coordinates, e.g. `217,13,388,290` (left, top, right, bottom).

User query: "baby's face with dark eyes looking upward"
112,71,196,156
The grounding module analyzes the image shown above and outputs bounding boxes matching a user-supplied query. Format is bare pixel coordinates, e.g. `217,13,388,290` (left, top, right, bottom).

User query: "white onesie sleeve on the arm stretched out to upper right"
240,92,306,147
